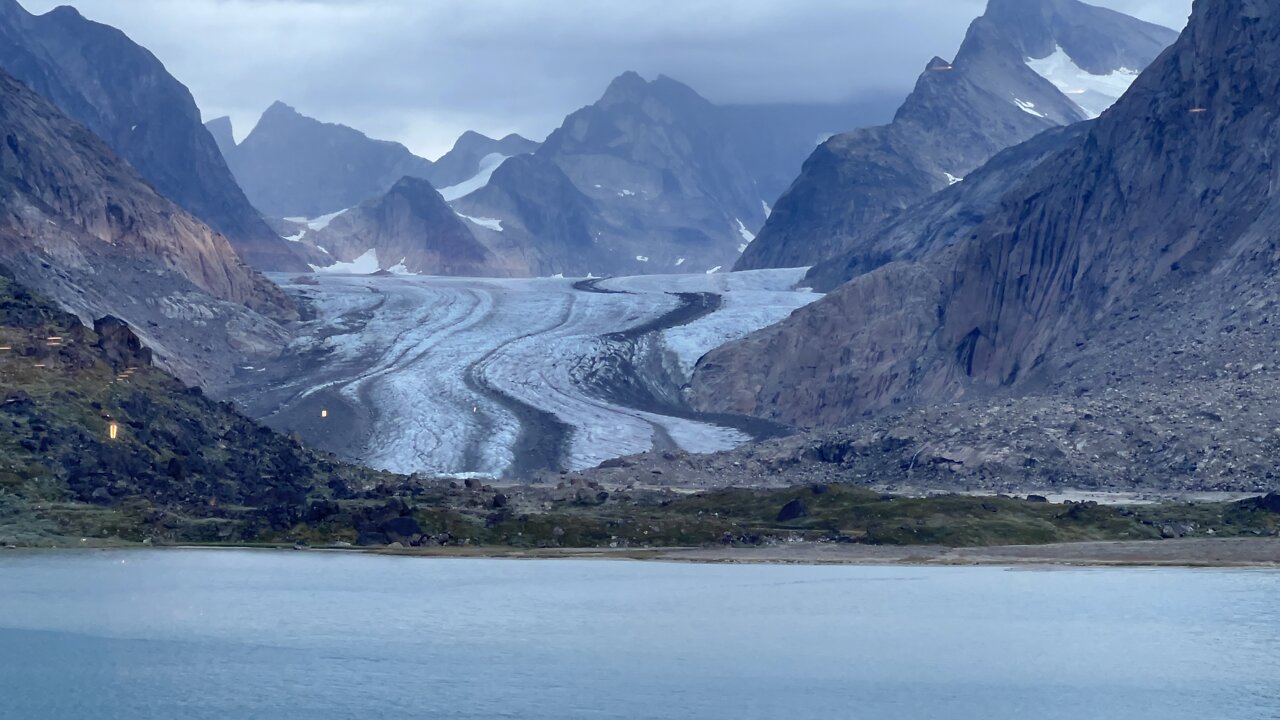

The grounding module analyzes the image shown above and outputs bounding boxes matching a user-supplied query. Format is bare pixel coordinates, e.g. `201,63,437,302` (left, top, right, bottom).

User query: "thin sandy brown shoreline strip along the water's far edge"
12,538,1280,570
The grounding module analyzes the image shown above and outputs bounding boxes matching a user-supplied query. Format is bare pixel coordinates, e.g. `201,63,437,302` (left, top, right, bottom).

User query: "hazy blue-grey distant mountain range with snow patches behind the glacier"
207,73,895,275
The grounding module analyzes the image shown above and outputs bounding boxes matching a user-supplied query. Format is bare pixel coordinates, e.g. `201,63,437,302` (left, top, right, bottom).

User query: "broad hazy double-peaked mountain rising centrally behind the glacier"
460,73,764,274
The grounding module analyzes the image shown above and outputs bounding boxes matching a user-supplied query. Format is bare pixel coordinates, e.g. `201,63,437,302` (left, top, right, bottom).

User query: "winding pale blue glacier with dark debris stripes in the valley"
236,269,819,477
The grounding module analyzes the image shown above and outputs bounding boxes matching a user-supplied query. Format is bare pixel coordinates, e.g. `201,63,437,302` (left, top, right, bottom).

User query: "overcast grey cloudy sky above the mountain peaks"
20,0,1190,159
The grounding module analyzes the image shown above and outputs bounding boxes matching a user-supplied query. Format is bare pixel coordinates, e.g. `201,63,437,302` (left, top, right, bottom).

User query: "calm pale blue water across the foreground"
0,551,1280,720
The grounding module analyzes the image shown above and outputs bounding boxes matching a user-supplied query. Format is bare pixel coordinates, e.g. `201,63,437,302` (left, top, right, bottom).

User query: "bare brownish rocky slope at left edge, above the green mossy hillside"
0,70,297,384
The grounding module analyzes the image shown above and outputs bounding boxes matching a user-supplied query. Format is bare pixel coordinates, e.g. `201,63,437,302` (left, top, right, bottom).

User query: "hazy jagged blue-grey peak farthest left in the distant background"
227,102,431,218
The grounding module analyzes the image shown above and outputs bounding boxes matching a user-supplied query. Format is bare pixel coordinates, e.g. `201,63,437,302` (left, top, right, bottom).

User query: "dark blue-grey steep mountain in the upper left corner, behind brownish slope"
0,0,305,270
